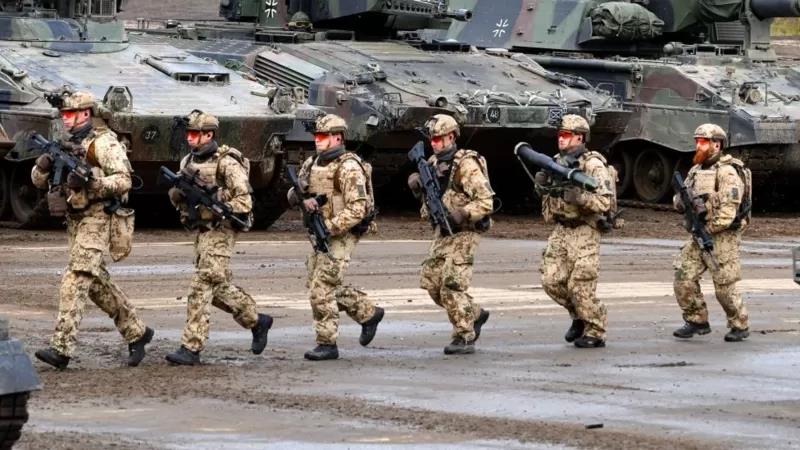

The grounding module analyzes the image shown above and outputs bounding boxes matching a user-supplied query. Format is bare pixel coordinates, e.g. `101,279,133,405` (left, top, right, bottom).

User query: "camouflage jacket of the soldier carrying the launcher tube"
542,149,616,228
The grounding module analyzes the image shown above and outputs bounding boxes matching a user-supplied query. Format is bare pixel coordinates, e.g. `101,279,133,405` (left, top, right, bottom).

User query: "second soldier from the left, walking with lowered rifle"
166,110,273,366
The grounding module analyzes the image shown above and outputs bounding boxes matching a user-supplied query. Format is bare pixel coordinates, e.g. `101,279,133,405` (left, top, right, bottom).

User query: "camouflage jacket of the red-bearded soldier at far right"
672,155,747,234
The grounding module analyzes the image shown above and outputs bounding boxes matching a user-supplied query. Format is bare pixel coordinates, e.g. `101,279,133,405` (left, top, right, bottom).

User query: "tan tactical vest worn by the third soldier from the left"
302,151,375,225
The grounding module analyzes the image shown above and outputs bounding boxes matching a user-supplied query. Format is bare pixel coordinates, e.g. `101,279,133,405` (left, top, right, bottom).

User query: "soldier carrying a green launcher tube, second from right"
534,114,616,348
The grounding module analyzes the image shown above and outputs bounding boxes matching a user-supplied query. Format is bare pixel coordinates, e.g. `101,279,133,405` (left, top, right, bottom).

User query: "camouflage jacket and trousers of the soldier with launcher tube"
540,146,616,341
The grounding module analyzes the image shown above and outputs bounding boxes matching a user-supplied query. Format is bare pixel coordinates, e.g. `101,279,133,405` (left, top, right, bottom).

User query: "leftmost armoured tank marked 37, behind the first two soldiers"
0,0,311,227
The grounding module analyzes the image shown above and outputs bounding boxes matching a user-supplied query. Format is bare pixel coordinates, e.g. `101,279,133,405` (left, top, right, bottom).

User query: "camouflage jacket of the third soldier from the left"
297,150,369,236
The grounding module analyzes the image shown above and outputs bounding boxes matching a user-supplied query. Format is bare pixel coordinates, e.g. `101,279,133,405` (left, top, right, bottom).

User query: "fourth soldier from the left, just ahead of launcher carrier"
408,114,494,355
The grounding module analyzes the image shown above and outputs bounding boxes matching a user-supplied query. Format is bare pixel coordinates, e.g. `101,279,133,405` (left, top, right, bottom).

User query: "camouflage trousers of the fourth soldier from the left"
419,231,481,341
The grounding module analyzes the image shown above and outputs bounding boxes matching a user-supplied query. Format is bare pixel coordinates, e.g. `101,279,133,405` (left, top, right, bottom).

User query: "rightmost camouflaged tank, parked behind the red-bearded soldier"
438,0,800,205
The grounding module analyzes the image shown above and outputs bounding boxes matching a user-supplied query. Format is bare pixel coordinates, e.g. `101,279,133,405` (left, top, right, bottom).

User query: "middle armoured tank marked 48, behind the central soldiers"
133,0,629,204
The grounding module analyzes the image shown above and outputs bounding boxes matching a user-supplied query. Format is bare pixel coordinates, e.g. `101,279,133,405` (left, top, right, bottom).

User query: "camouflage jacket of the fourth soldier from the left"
421,149,494,223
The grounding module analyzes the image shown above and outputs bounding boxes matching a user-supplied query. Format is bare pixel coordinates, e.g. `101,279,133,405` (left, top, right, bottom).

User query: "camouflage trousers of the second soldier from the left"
181,227,258,352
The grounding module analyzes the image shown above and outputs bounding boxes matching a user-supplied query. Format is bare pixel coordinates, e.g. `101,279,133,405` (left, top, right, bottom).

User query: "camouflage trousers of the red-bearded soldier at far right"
673,231,749,330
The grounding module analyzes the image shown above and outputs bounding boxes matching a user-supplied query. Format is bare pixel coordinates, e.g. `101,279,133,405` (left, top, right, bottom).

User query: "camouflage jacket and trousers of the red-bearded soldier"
673,155,749,330
